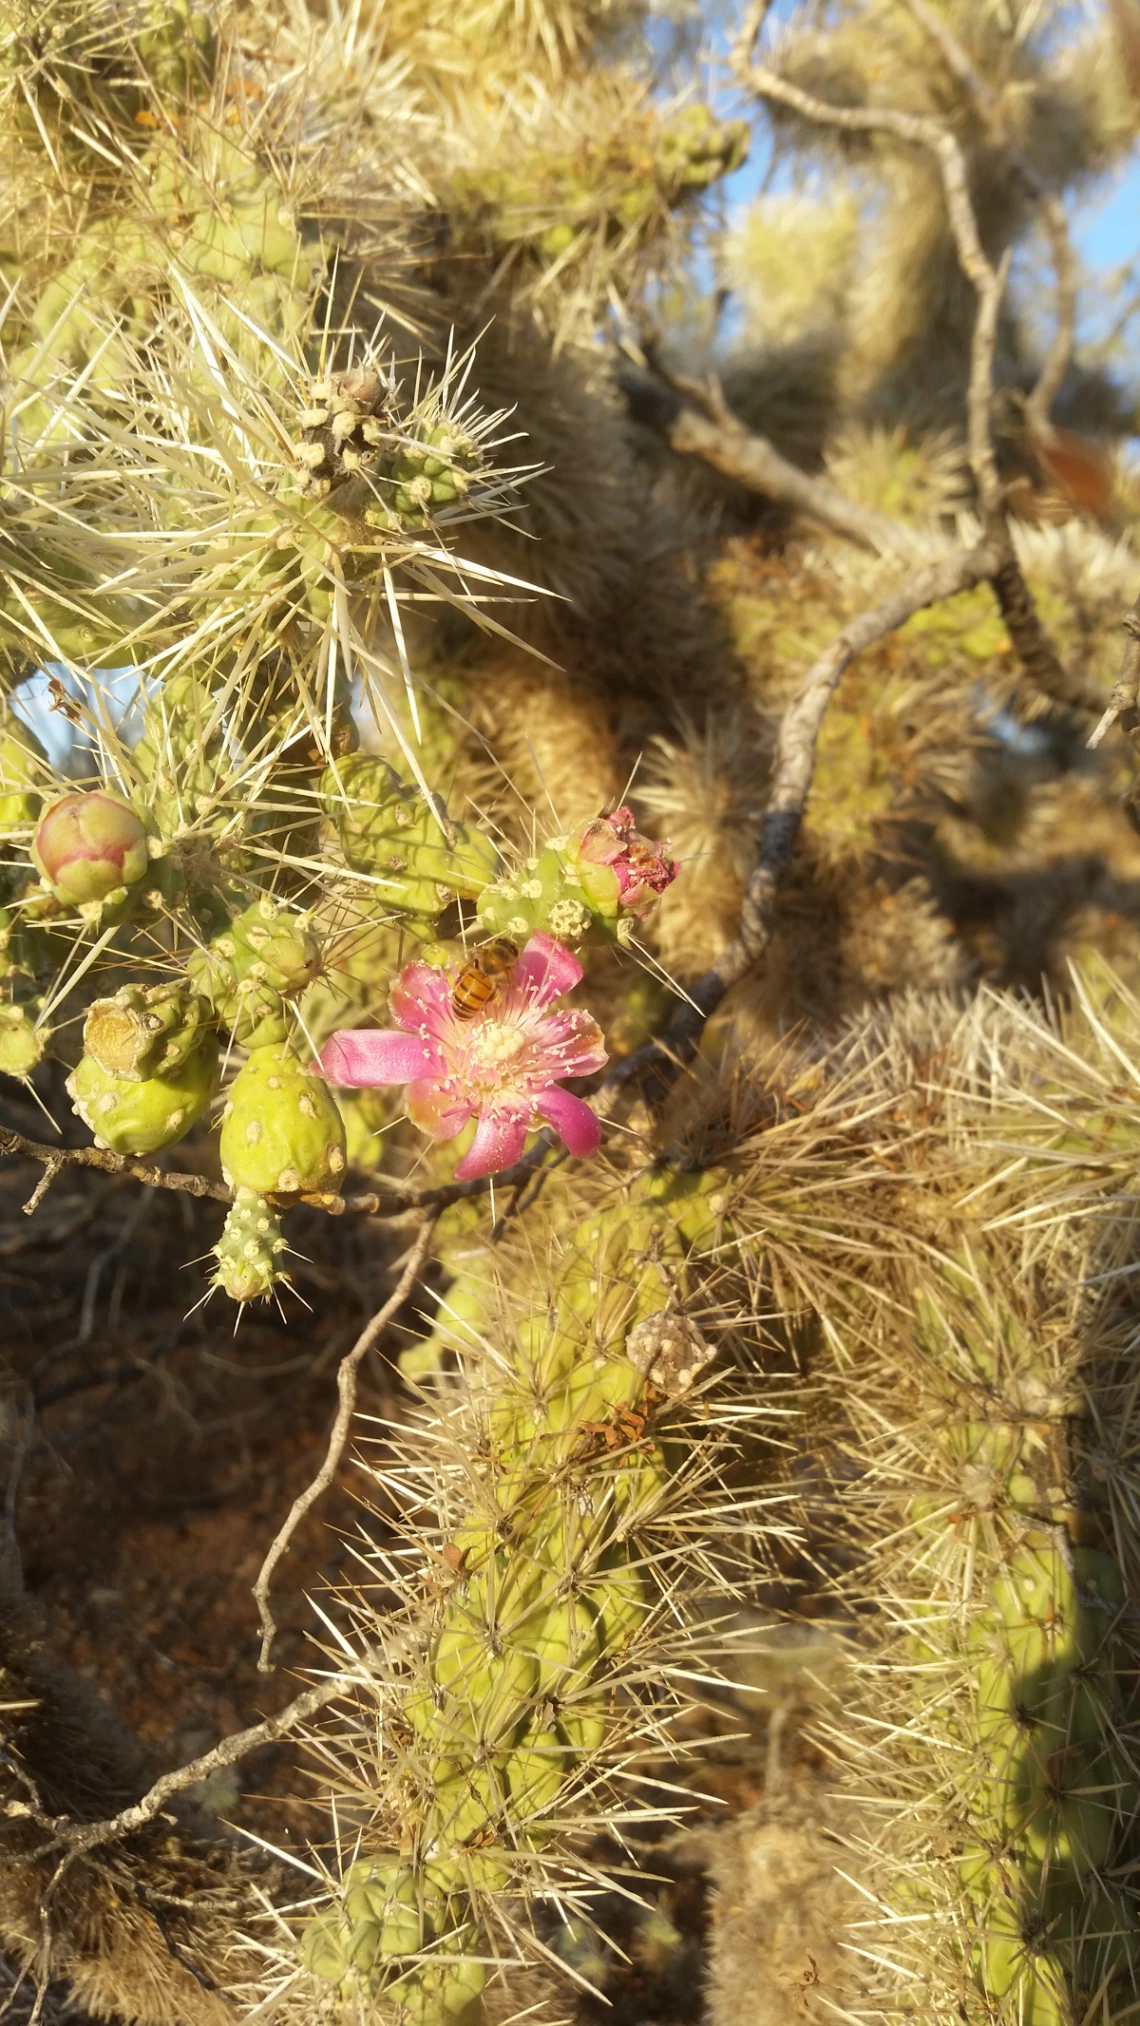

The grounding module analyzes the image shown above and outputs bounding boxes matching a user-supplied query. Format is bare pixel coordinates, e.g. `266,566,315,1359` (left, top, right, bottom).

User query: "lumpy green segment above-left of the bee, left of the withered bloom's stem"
320,754,498,916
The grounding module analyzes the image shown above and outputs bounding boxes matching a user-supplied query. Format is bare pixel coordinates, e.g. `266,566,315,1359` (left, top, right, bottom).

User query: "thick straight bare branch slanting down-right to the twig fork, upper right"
622,364,913,553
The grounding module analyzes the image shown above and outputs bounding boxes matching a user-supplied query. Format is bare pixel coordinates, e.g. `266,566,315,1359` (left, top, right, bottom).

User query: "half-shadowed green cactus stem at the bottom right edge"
962,1528,1140,2020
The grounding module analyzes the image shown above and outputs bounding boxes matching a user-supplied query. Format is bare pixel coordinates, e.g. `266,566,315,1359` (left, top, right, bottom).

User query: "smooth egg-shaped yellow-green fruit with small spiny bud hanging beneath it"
221,1041,344,1195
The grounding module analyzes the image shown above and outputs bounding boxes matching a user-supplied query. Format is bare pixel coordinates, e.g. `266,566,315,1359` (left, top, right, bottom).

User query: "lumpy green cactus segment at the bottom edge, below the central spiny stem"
302,1858,486,2026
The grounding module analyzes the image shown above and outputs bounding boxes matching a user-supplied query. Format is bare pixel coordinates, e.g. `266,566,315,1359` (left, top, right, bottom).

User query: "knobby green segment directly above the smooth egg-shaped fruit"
186,893,320,1049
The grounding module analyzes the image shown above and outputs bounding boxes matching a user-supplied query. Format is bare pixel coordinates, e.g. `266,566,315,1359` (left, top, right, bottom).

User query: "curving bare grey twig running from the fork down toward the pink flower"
603,543,998,1108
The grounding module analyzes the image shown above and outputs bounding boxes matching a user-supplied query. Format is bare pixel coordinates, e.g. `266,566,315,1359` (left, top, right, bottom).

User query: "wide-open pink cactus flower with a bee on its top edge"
318,932,607,1181
